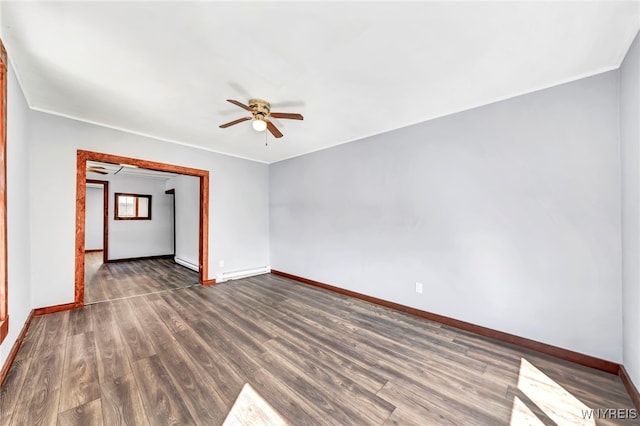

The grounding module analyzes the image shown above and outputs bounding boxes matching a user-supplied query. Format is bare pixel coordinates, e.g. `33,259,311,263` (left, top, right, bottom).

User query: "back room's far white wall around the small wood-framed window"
108,175,173,260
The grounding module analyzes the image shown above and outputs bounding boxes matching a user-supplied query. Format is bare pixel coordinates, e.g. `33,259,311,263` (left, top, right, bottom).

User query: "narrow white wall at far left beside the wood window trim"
0,61,32,366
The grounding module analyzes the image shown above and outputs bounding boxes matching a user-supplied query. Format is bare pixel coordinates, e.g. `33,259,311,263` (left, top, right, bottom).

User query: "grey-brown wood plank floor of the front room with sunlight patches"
0,275,639,426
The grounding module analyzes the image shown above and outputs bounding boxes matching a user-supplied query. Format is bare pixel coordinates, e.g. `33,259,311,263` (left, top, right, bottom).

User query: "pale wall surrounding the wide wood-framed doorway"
29,112,269,307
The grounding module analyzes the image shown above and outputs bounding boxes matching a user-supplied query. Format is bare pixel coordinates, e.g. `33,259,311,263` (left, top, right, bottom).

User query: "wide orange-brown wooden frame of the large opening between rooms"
73,150,210,308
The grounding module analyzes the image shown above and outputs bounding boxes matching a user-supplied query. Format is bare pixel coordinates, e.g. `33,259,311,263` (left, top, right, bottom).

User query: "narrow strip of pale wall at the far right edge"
620,31,640,389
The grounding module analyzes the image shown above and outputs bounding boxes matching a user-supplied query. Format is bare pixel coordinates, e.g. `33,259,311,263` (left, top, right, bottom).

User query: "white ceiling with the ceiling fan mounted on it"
0,1,640,163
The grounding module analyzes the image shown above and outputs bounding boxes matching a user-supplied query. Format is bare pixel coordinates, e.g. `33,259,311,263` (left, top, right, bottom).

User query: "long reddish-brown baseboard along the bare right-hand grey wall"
271,269,620,374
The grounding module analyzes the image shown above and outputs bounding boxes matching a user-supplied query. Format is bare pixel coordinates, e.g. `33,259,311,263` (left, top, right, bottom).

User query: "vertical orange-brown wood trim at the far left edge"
0,36,9,343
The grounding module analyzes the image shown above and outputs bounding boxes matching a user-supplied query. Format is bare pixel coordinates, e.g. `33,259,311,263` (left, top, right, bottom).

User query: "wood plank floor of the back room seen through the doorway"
84,252,198,304
